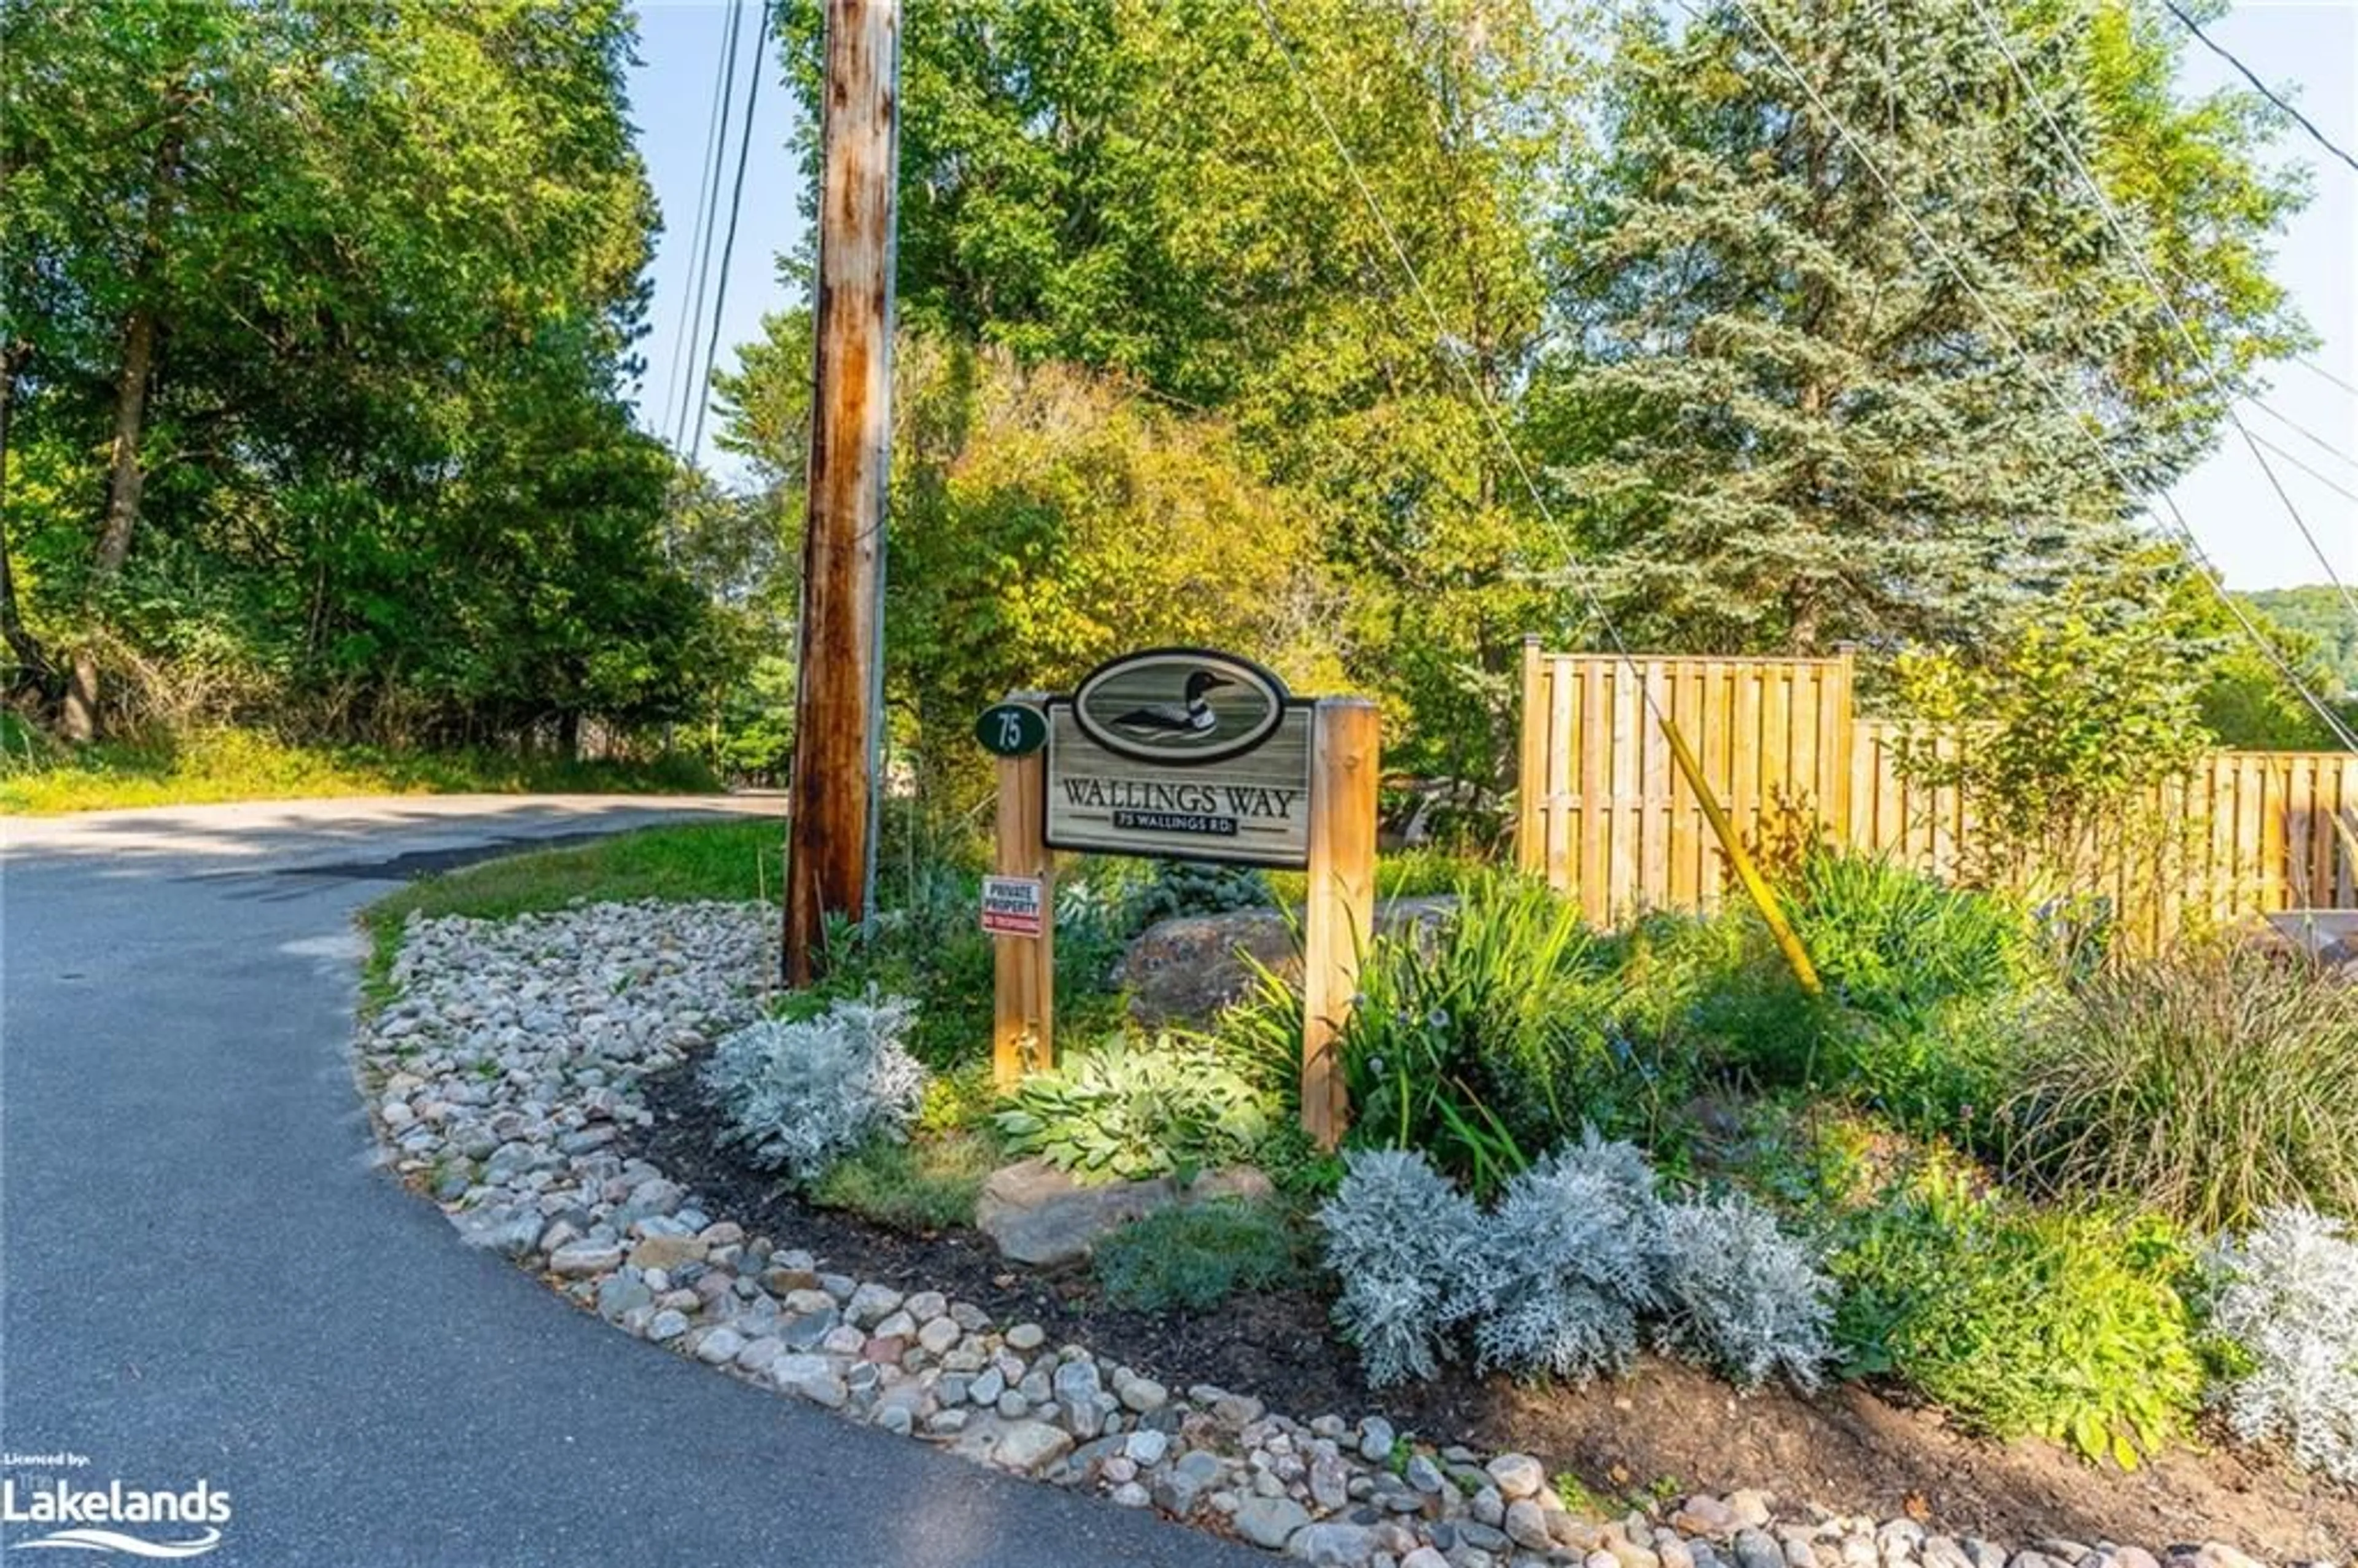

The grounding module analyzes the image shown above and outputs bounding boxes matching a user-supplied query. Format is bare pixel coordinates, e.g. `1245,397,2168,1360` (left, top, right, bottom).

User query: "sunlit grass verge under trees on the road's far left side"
0,719,712,816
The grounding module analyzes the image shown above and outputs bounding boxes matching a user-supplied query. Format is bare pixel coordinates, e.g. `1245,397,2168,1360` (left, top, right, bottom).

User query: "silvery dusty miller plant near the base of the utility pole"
702,995,924,1181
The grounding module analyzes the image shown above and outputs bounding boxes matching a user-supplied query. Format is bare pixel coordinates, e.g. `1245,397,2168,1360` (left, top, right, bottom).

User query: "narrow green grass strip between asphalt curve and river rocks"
361,818,785,1007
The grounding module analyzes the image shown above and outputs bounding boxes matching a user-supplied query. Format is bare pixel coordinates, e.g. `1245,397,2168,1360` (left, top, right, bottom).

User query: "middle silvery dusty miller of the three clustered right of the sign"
1457,1130,1662,1382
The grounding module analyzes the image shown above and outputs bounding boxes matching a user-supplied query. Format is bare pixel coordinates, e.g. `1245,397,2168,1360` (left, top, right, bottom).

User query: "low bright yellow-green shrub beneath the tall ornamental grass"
1830,1172,2200,1469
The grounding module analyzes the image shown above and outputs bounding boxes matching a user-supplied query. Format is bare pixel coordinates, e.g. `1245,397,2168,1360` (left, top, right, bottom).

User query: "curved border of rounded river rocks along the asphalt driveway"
356,903,2325,1568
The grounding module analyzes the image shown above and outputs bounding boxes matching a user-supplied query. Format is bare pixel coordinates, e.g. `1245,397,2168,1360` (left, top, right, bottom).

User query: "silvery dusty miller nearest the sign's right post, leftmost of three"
1318,1148,1483,1386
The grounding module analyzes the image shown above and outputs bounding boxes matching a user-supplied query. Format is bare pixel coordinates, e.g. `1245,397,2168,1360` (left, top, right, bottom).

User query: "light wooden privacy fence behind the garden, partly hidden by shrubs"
1516,642,2358,941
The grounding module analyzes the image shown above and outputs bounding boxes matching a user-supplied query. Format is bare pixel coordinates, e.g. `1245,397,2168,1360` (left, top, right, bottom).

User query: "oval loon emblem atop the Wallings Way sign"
1073,648,1288,766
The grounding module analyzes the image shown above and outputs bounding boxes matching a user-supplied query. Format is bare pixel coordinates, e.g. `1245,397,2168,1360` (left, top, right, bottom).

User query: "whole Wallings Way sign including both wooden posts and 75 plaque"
976,648,1379,1148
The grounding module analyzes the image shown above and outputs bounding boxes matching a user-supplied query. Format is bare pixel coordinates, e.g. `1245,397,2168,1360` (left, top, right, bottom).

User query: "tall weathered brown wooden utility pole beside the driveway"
785,0,901,985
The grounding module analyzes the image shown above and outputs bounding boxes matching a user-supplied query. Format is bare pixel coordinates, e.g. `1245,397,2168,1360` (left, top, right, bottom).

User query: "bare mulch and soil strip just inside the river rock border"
634,1066,2358,1563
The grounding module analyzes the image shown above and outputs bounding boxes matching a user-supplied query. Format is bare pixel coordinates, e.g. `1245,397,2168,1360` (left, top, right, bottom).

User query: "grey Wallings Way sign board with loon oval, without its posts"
1047,648,1311,867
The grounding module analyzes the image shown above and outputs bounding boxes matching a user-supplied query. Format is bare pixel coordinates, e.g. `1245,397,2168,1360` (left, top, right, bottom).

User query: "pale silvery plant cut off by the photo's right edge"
2203,1209,2358,1486
